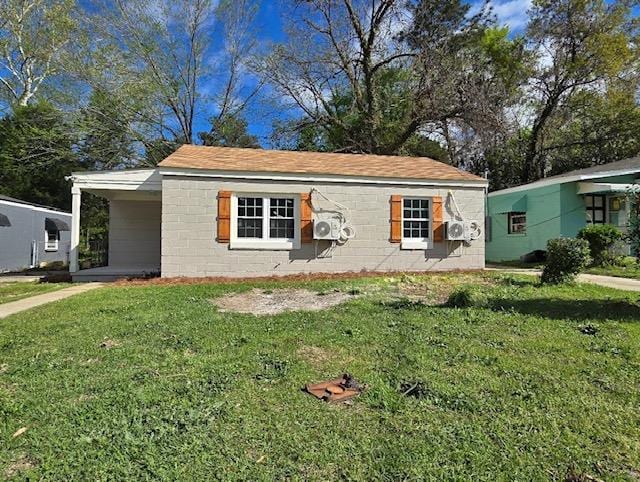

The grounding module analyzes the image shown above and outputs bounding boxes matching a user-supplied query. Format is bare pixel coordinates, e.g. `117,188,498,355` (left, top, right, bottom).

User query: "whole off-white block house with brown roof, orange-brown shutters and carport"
71,145,487,281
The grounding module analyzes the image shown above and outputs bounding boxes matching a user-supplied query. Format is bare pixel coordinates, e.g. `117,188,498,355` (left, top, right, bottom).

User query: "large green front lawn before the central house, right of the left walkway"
0,275,640,480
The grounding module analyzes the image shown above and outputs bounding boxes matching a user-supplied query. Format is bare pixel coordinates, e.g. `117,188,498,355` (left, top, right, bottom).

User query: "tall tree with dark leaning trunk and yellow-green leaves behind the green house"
520,0,637,183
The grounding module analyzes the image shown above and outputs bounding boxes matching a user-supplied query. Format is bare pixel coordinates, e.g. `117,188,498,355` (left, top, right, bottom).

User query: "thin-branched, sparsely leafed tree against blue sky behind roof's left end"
88,0,214,143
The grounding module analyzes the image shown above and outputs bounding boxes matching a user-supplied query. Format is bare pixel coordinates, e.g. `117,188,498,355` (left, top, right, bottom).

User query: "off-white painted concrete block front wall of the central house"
161,176,484,277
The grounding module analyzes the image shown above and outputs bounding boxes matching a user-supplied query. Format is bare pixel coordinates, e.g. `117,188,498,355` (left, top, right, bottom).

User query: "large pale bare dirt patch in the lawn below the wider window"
211,289,356,315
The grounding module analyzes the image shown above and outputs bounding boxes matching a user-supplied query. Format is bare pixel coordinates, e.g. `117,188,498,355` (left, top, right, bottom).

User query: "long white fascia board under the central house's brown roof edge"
160,168,488,188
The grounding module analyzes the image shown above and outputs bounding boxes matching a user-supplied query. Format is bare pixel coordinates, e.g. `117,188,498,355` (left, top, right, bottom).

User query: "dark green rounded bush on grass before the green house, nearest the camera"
541,238,591,284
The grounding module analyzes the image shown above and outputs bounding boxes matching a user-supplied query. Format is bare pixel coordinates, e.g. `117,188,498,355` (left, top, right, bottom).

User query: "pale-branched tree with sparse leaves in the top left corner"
0,0,77,107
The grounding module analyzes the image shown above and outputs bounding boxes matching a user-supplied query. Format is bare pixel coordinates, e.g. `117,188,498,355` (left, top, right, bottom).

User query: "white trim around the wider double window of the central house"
229,192,301,251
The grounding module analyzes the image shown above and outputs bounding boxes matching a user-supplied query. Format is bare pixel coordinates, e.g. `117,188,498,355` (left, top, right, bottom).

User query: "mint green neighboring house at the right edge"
486,157,640,261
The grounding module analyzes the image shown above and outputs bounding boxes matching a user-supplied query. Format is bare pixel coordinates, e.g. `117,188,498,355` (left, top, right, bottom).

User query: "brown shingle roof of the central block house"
159,145,484,181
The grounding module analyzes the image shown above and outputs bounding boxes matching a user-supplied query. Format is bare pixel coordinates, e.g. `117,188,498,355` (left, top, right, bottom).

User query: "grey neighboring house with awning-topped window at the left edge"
0,195,71,273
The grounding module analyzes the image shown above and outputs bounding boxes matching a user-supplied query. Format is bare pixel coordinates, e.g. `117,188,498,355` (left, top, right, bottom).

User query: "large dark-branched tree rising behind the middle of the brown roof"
262,0,523,164
